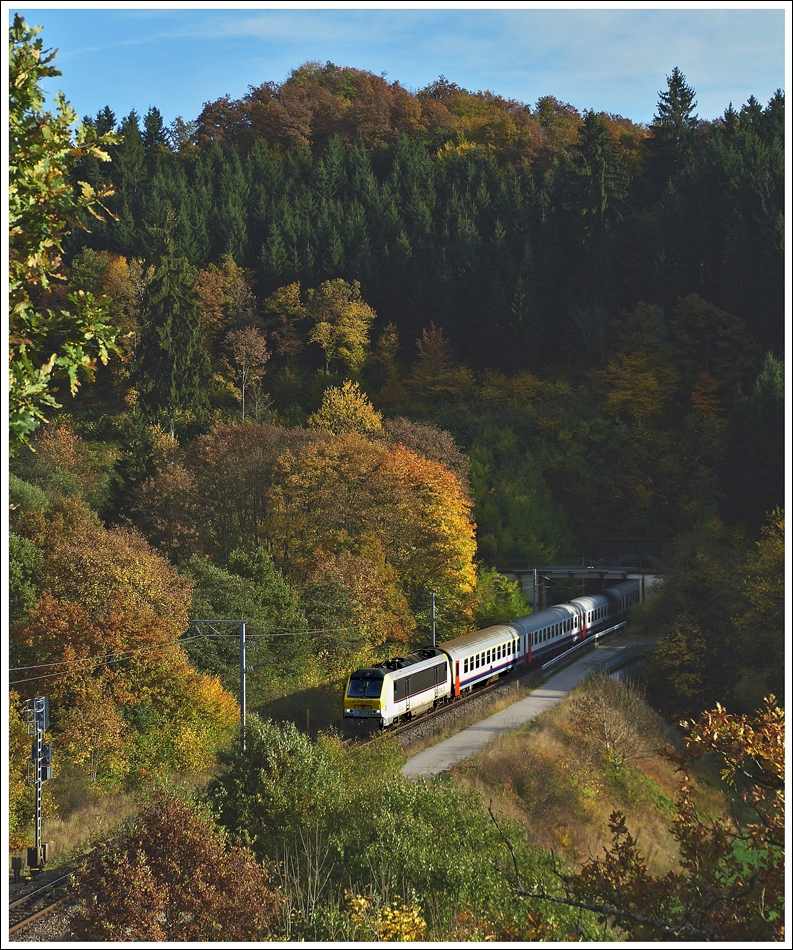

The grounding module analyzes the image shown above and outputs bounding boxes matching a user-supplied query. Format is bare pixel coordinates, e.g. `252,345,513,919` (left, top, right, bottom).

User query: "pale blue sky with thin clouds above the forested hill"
9,0,790,131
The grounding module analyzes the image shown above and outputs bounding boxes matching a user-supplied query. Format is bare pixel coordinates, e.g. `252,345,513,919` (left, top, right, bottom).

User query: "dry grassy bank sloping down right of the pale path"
448,678,723,873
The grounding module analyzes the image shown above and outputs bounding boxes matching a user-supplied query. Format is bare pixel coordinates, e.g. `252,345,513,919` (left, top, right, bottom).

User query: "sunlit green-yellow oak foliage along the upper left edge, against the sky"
9,14,117,452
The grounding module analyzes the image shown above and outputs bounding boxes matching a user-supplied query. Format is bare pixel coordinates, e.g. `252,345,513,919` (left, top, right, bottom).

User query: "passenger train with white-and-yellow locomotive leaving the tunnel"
344,580,639,729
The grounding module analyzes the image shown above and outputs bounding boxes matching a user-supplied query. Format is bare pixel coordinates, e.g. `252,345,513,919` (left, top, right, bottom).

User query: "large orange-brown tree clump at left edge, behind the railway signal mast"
11,498,237,784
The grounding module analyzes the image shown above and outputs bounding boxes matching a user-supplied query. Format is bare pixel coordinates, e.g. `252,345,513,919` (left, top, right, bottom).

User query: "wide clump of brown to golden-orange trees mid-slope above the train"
138,422,476,632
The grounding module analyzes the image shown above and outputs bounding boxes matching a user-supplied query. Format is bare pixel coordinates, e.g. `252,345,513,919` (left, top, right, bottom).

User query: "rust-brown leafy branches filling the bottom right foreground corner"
510,696,785,942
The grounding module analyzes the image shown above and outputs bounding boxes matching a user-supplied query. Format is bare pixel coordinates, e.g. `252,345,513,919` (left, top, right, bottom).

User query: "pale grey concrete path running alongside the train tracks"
402,640,649,779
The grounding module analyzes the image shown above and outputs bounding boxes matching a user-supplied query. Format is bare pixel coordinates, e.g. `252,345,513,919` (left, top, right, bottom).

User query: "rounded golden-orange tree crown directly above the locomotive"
268,433,476,609
